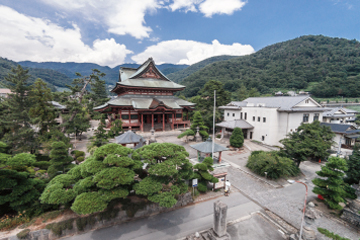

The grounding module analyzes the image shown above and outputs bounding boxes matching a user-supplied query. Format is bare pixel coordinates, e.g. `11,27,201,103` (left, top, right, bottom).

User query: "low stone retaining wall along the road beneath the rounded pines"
0,192,193,240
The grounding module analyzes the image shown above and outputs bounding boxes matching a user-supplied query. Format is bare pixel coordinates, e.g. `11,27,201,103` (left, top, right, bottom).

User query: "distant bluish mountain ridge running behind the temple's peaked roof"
19,61,188,85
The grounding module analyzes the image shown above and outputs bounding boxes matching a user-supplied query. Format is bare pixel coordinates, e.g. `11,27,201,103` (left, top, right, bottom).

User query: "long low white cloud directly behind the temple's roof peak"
131,40,255,65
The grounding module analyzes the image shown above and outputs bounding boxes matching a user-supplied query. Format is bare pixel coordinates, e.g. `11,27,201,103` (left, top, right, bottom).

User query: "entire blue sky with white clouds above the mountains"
0,0,360,67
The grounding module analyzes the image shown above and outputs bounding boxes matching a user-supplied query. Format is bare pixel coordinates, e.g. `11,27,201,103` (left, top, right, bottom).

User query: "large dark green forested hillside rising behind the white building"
180,35,360,97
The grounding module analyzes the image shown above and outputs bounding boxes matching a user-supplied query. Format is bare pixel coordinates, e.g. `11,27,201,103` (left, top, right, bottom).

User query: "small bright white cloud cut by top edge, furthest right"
199,0,245,17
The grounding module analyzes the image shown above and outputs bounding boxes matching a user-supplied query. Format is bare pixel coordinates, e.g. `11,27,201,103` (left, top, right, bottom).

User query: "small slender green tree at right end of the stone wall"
193,157,219,192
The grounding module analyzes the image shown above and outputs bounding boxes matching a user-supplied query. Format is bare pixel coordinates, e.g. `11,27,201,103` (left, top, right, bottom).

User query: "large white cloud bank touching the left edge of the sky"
0,5,132,67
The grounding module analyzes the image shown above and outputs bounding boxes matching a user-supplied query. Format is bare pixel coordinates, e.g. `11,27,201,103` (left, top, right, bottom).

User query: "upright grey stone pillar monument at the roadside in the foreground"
202,201,231,240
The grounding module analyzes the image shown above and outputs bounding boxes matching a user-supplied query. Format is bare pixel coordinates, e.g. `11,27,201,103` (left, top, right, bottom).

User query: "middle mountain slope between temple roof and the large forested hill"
167,55,239,83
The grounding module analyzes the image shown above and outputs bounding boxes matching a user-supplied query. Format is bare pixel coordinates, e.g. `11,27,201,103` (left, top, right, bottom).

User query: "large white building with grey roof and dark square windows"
216,95,329,146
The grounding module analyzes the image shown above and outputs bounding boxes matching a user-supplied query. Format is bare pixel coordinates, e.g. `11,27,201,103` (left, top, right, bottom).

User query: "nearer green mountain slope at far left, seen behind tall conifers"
0,57,72,91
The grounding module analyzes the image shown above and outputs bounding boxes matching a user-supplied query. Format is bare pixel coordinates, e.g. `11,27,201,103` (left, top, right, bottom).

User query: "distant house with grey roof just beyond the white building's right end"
323,108,358,124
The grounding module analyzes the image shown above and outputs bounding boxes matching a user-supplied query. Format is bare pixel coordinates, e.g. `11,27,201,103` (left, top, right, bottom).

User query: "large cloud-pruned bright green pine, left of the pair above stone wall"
40,143,142,214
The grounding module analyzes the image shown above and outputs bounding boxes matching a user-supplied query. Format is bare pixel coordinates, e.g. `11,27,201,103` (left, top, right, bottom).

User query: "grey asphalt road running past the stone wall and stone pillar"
65,192,261,240
